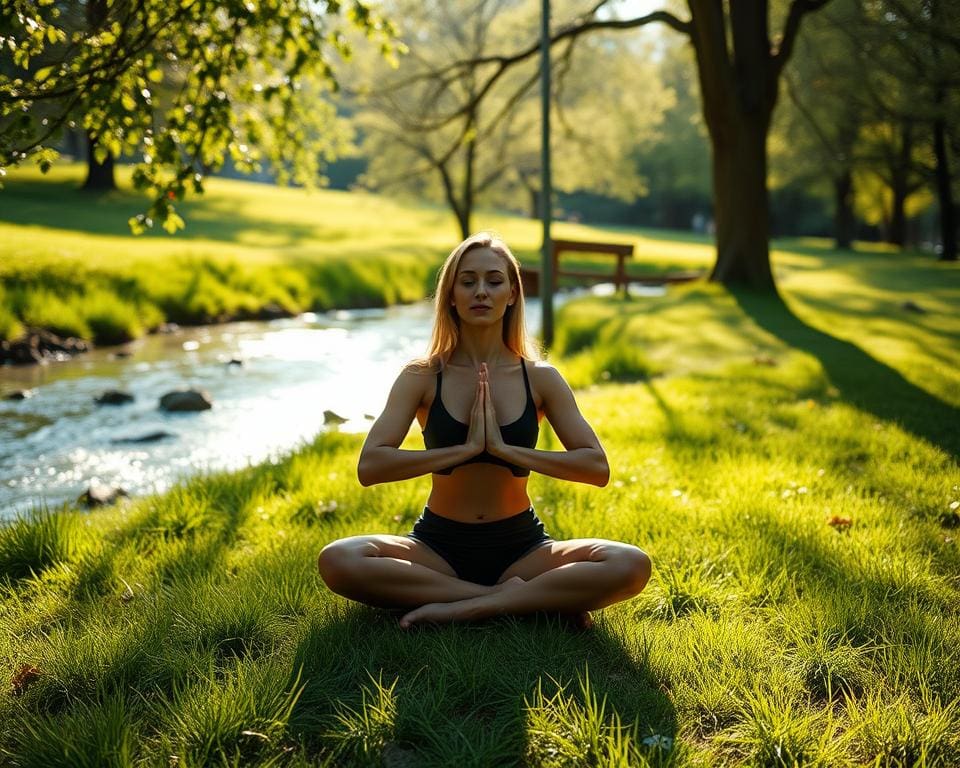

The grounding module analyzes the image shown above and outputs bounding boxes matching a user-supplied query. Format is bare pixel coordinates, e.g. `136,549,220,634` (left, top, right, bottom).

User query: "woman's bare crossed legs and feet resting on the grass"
318,535,650,627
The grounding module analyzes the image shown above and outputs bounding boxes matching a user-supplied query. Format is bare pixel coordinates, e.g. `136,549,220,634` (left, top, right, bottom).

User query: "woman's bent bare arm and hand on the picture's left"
357,371,483,486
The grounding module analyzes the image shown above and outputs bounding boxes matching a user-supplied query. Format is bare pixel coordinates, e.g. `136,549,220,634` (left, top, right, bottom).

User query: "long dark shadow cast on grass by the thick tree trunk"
731,288,960,462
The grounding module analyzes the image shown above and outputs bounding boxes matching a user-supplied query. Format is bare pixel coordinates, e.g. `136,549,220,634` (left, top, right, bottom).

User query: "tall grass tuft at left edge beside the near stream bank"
0,508,77,579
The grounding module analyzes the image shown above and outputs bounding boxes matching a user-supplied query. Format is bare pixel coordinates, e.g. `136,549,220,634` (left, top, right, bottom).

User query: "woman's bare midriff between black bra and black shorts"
427,463,530,523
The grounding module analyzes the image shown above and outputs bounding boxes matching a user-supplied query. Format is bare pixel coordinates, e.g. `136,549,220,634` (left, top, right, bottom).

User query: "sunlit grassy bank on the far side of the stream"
0,165,709,344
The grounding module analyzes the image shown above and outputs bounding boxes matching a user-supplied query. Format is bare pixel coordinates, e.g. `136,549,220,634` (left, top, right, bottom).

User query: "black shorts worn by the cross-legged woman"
407,507,553,586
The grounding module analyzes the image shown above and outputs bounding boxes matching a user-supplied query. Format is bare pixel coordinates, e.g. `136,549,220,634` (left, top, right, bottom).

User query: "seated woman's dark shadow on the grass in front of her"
290,605,677,766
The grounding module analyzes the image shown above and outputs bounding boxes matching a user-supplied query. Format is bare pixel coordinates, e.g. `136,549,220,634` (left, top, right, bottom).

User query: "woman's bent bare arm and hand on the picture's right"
481,366,610,487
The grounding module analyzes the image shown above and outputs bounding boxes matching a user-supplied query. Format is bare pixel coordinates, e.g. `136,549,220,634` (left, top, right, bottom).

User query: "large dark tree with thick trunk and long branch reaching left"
394,0,829,292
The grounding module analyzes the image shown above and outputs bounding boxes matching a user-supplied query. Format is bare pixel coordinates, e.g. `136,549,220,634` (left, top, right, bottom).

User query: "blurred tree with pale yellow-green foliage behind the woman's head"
353,0,672,237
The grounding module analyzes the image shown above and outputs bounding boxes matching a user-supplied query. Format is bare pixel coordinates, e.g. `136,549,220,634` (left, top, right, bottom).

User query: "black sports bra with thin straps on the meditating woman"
423,357,540,477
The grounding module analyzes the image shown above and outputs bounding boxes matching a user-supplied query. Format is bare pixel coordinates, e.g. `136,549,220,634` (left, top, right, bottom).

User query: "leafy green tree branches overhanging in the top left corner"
0,0,392,232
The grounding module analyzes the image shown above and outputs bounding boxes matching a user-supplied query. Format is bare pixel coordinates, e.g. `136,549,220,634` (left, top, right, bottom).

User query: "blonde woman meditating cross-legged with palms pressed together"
319,233,650,628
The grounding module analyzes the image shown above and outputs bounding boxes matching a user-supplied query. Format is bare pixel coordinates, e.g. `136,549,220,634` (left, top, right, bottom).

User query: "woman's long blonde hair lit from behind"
410,232,540,371
